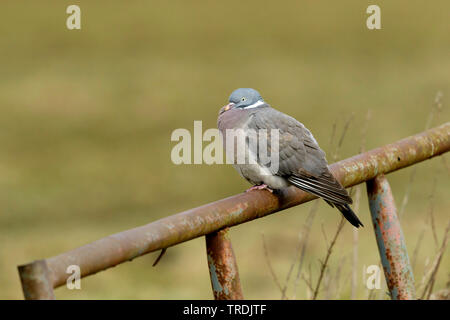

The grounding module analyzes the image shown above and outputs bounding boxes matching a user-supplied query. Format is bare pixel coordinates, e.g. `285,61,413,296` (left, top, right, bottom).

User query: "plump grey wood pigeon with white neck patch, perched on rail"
217,88,363,228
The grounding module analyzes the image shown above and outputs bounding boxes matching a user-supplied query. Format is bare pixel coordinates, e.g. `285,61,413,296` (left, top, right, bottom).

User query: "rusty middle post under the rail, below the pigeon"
205,228,244,300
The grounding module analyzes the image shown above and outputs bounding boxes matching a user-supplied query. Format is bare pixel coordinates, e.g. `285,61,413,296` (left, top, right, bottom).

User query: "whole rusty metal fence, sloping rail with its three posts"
18,122,450,299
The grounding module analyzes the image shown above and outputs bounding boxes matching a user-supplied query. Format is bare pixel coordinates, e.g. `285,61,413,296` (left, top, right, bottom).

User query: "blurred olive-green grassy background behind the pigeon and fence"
0,0,450,299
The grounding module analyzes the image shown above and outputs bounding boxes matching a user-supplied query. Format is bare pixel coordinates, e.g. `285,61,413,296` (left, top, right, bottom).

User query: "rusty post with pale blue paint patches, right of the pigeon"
367,174,416,300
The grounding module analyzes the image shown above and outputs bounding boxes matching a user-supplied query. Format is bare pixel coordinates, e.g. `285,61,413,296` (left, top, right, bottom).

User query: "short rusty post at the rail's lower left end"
18,260,55,300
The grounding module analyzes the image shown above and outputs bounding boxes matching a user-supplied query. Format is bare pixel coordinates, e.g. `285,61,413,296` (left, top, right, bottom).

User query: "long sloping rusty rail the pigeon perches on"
33,122,450,287
